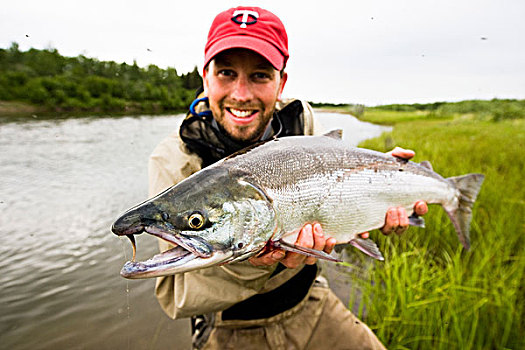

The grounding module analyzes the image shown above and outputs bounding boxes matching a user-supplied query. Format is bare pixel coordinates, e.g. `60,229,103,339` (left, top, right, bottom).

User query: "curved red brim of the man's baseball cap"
204,35,284,71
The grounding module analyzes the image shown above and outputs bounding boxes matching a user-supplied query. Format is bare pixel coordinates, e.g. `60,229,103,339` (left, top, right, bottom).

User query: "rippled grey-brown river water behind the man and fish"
0,113,386,349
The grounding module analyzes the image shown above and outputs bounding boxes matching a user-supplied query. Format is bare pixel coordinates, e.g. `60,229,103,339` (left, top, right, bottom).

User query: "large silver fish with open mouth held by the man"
112,132,484,278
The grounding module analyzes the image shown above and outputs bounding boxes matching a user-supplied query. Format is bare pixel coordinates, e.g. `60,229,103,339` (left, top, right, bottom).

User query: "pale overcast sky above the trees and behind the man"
0,0,525,105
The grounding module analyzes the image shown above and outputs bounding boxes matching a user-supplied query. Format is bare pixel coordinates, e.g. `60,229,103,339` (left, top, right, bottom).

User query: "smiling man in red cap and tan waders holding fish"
149,7,427,349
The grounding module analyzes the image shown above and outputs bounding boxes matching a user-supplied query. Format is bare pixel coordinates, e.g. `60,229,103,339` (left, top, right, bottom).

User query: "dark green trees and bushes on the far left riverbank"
0,43,201,113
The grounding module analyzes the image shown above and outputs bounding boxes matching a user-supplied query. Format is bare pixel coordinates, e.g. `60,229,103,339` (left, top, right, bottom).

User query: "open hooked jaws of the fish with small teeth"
118,223,233,279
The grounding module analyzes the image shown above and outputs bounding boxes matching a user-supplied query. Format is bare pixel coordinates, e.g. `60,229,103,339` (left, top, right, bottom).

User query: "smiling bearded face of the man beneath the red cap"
204,49,287,142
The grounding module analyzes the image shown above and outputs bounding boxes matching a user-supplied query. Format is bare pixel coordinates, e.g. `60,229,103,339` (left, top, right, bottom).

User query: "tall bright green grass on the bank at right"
348,110,525,349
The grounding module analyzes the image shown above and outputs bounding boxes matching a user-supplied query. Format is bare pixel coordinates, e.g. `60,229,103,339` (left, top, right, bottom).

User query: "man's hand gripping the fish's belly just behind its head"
249,223,336,269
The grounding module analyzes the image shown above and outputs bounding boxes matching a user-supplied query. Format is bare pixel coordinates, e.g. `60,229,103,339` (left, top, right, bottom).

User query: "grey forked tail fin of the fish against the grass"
445,174,485,250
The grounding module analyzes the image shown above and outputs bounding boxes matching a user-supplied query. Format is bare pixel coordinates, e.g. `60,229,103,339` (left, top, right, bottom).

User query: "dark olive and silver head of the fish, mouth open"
112,166,277,279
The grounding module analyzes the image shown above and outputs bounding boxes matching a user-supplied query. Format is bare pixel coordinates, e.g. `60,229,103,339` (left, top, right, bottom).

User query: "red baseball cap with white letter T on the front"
204,6,289,71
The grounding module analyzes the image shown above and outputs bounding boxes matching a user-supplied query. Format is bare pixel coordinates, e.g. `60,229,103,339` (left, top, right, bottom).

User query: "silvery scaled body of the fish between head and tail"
224,137,457,243
